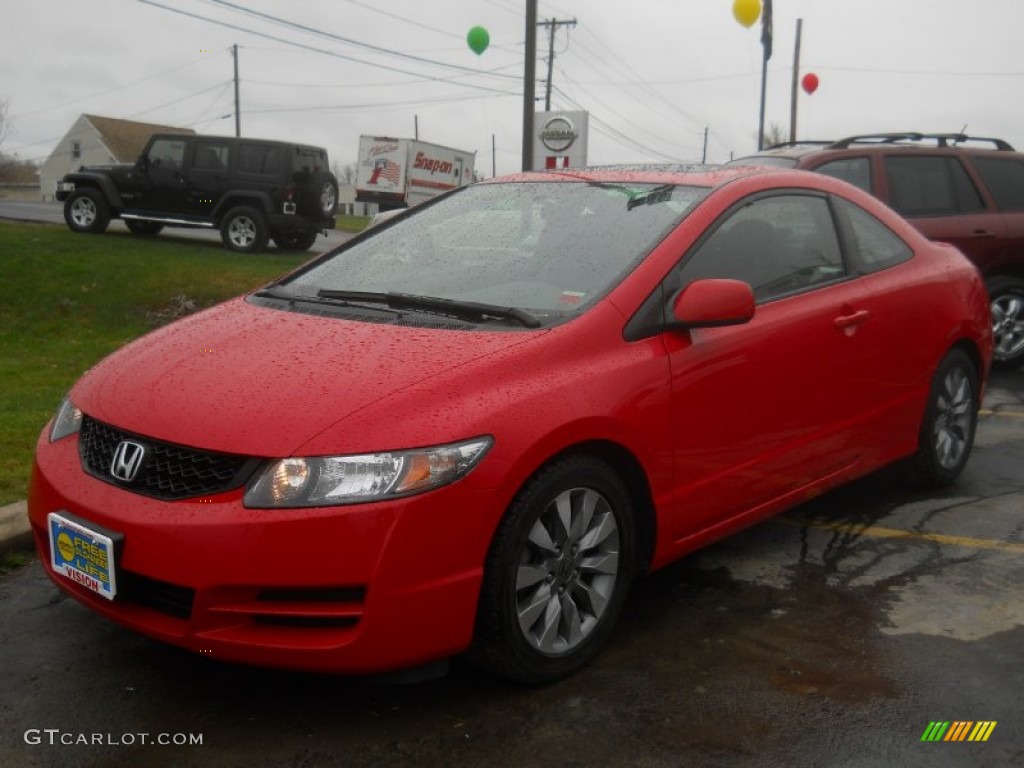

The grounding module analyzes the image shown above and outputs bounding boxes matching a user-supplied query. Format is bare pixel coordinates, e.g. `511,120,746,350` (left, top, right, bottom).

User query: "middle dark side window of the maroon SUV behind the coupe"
885,155,985,216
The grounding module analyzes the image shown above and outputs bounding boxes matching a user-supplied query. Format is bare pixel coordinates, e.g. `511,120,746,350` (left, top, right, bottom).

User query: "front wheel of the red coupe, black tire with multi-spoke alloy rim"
469,455,636,684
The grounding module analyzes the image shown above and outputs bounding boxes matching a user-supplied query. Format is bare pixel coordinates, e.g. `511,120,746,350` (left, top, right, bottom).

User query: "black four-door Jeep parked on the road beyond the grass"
56,133,338,253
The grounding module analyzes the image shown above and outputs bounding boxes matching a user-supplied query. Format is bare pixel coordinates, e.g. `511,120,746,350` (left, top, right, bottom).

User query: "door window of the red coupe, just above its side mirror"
669,195,847,302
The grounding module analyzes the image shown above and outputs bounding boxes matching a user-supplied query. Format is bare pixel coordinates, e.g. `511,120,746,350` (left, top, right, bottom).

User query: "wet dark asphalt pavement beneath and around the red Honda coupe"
0,372,1024,768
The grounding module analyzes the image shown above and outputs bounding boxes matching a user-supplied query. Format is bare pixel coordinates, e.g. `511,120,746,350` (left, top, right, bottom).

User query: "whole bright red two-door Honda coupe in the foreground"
29,167,992,683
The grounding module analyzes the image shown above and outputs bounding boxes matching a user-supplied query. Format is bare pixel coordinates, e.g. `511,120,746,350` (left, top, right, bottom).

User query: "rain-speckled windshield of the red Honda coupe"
284,182,709,319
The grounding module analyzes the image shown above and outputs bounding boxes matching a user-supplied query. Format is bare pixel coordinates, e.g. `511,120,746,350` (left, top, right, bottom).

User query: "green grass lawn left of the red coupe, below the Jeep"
0,221,312,506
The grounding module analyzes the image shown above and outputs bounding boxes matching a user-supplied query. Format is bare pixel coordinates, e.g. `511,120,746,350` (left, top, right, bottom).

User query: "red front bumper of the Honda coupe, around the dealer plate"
29,434,496,674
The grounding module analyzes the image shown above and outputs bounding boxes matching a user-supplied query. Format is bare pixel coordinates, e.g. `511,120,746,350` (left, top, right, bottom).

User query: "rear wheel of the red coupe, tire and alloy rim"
904,348,980,487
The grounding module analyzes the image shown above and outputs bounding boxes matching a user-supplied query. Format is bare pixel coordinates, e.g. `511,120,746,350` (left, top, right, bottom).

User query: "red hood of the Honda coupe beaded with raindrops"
72,299,544,457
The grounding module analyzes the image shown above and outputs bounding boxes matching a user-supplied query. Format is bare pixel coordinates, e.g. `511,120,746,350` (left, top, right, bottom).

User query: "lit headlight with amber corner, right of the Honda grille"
245,437,493,508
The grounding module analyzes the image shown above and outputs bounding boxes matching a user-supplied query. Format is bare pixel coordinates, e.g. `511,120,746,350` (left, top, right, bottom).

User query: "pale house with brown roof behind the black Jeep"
39,115,196,200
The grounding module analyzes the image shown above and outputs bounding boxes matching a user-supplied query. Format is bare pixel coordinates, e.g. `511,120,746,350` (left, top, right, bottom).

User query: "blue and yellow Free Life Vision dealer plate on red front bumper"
46,512,121,600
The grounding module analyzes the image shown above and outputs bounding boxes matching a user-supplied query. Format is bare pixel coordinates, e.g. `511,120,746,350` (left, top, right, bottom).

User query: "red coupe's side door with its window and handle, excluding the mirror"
665,191,885,541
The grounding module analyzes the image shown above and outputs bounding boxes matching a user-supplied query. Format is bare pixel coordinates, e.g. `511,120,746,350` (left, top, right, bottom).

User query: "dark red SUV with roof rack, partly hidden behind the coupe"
732,133,1024,367
